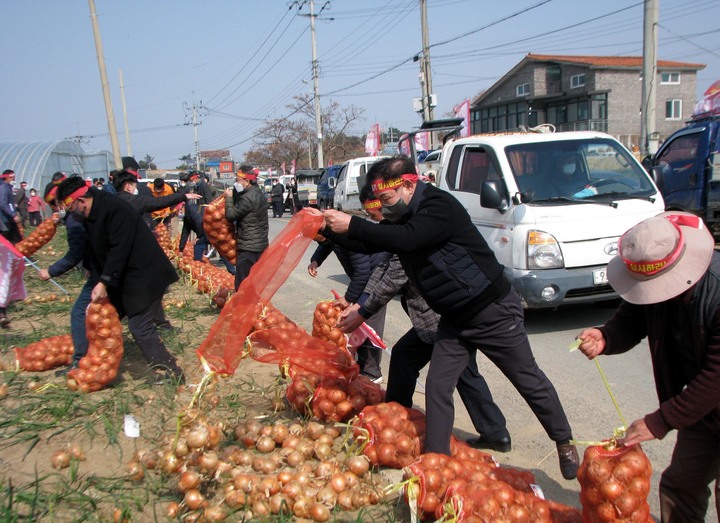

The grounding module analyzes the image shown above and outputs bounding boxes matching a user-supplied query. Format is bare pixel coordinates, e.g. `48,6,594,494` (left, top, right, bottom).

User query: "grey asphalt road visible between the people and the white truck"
258,211,716,521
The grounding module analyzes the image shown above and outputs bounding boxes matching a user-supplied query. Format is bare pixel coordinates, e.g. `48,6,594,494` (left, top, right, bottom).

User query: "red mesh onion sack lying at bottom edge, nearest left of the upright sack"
435,478,552,523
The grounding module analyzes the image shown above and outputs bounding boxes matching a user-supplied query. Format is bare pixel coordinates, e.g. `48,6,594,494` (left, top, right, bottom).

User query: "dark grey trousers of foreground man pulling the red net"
425,290,572,454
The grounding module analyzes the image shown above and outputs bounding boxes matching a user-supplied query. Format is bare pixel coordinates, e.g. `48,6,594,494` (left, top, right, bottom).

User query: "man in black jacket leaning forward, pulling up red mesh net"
323,156,580,479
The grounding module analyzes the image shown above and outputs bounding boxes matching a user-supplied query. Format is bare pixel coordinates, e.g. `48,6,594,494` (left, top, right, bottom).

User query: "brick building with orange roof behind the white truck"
470,54,705,148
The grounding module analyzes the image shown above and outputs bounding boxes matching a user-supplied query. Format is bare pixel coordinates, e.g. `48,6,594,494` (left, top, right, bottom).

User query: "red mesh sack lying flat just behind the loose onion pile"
247,327,359,380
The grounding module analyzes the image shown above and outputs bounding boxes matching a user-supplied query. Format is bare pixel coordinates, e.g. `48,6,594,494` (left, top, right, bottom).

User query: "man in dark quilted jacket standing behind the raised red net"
225,164,269,290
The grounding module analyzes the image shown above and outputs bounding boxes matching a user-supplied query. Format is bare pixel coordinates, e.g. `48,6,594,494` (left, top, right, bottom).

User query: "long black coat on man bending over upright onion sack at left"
83,187,178,316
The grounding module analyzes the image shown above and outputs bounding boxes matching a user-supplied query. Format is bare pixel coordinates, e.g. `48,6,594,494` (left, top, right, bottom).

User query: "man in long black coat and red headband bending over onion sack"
57,176,184,382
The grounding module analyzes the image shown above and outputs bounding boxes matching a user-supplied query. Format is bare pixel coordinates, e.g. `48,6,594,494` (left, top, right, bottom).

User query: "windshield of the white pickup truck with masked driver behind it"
505,138,656,204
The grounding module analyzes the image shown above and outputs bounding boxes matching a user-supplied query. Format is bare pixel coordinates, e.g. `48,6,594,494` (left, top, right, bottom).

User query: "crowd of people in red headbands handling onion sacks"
0,156,720,522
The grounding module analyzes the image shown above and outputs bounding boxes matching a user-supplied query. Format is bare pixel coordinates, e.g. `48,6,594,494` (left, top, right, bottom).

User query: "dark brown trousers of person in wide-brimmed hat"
660,422,720,523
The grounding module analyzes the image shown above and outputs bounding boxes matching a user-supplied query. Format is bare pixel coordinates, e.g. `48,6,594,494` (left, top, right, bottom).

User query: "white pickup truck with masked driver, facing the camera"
438,132,664,308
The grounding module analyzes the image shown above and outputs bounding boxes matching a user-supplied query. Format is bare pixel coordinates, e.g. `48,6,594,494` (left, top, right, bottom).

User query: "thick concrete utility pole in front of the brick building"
640,0,660,157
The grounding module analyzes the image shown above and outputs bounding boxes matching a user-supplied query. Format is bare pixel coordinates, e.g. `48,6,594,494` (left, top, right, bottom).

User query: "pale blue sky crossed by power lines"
0,0,720,169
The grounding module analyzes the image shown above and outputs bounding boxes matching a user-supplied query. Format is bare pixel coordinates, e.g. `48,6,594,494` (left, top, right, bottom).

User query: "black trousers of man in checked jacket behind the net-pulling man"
385,328,510,440
